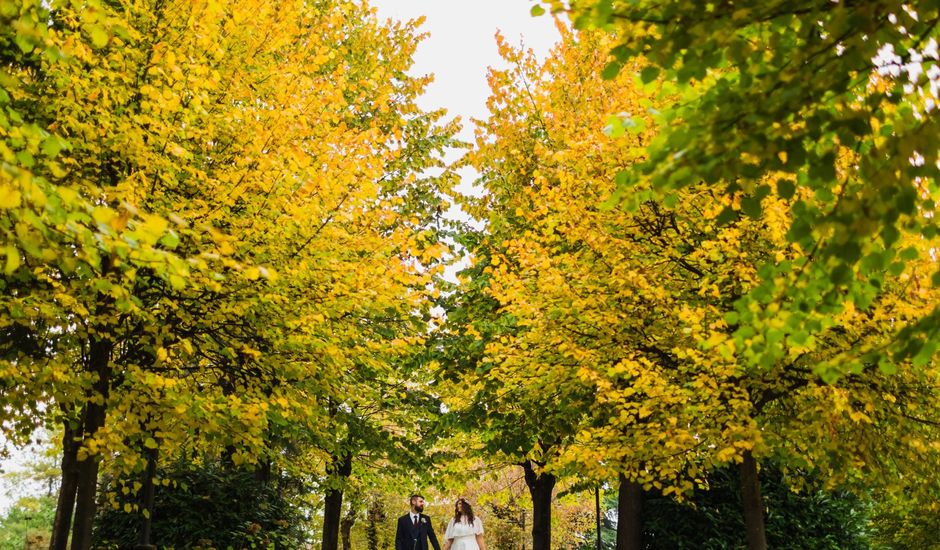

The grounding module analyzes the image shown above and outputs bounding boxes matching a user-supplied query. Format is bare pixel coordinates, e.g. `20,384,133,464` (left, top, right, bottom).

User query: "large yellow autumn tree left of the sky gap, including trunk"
4,1,455,548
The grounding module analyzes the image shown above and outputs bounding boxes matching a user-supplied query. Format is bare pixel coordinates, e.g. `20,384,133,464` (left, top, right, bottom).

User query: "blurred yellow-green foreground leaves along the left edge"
0,1,221,452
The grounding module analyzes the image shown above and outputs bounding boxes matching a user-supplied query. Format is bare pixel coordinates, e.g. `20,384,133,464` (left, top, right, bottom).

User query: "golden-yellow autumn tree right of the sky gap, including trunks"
470,21,937,548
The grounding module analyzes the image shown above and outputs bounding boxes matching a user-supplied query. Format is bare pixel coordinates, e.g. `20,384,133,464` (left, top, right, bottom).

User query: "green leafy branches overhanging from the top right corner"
534,0,940,380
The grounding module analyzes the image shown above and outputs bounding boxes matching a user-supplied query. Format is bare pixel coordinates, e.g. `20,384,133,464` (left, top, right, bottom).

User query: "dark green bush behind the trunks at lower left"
95,463,309,549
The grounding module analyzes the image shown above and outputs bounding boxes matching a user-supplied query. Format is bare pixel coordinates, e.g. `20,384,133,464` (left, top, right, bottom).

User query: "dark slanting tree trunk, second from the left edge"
72,337,114,550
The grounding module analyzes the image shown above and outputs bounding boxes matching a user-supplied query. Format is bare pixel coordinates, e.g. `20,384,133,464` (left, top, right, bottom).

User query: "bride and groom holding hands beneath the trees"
395,495,486,550
